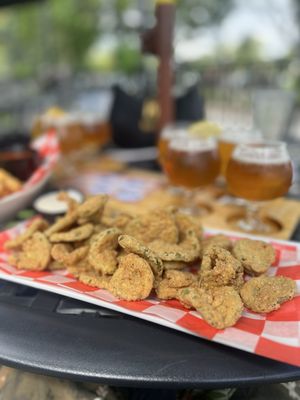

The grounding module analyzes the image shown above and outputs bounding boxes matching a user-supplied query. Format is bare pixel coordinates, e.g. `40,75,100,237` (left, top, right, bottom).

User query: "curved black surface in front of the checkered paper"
0,280,300,389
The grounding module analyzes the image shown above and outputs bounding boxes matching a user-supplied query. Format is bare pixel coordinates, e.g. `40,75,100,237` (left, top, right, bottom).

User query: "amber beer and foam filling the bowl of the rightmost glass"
226,143,292,201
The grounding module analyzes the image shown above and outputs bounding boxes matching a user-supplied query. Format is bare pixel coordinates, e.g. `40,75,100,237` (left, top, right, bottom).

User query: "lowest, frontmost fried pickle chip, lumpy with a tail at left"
178,286,243,329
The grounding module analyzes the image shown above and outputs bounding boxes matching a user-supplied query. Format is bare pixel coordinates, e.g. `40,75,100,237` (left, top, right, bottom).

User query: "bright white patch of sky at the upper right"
175,0,299,61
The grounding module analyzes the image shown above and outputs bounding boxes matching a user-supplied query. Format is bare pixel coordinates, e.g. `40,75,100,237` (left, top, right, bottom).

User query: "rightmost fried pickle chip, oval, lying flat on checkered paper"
240,275,296,313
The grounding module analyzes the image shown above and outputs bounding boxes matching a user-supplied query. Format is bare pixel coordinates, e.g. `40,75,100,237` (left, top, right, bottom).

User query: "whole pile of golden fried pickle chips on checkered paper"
5,193,296,329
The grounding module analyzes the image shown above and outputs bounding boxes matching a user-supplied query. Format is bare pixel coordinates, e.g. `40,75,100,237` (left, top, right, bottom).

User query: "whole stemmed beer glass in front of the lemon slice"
163,132,220,215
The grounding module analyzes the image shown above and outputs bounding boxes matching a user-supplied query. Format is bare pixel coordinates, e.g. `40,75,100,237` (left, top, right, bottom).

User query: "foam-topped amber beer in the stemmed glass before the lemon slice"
165,138,220,189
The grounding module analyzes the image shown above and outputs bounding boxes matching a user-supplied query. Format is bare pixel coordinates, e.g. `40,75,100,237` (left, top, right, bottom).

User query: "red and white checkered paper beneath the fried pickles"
0,223,300,367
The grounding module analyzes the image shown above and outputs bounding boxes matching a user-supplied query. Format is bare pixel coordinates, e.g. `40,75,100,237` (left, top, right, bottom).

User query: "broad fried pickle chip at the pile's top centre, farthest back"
124,209,178,244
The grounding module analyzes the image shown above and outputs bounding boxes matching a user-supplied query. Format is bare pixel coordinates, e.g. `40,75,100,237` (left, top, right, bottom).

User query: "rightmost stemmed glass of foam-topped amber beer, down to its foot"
226,141,293,233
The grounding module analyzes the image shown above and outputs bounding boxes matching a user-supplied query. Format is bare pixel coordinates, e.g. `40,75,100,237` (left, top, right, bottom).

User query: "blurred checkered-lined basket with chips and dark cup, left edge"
0,130,59,222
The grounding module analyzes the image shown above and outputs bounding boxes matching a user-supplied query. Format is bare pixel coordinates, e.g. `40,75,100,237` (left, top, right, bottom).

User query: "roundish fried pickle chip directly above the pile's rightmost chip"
233,239,275,276
